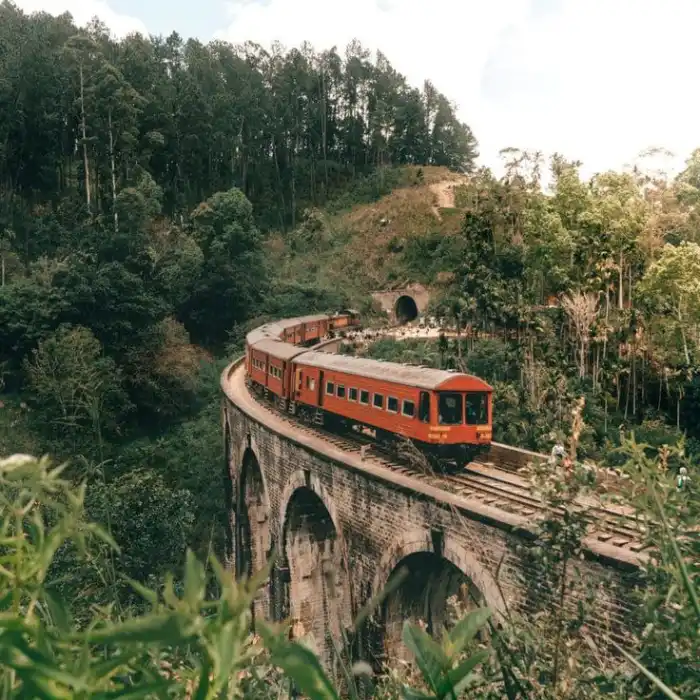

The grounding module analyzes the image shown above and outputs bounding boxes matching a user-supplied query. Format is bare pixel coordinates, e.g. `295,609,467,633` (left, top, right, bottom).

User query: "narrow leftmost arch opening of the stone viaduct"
236,447,272,616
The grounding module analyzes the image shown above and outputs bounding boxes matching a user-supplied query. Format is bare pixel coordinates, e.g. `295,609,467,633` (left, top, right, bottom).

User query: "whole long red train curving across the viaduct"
246,311,493,466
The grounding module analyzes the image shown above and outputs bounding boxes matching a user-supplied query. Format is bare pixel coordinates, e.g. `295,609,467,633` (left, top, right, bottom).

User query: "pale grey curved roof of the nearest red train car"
297,350,492,391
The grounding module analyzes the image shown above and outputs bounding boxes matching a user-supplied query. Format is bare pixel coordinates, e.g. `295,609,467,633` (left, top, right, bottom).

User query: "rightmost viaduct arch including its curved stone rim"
365,531,504,661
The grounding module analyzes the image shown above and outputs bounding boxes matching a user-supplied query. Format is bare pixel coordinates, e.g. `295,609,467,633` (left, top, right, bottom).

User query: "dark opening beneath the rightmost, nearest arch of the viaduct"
375,552,483,664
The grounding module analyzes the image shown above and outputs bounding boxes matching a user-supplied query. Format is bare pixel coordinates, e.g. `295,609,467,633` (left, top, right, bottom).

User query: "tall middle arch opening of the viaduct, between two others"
280,473,351,667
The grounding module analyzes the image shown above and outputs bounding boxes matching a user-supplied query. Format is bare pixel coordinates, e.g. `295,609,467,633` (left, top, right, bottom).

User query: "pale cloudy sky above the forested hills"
15,0,700,176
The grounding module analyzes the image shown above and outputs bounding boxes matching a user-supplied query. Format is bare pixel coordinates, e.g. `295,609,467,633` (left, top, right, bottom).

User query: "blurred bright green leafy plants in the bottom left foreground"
0,456,288,699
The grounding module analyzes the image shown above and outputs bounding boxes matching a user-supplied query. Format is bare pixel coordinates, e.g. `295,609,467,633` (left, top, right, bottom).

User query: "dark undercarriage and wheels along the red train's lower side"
246,378,489,473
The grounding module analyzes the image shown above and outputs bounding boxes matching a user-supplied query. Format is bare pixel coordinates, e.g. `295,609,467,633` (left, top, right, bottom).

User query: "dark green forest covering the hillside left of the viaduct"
0,2,476,602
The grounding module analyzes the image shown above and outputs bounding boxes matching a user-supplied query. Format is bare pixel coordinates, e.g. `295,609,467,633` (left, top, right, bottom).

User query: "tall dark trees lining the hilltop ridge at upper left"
0,3,477,235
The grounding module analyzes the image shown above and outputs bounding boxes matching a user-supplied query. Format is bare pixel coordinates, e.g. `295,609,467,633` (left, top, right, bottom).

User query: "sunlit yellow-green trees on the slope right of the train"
322,149,700,463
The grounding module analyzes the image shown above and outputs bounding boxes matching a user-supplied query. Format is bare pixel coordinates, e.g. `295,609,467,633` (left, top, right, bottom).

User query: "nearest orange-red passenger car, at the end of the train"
290,351,493,461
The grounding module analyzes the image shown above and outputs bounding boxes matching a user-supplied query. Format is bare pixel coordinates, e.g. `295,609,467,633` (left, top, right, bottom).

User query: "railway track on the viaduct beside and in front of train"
246,383,645,553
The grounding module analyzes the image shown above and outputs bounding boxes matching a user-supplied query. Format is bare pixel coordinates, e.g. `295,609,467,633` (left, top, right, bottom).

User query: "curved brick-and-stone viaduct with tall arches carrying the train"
222,361,639,669
